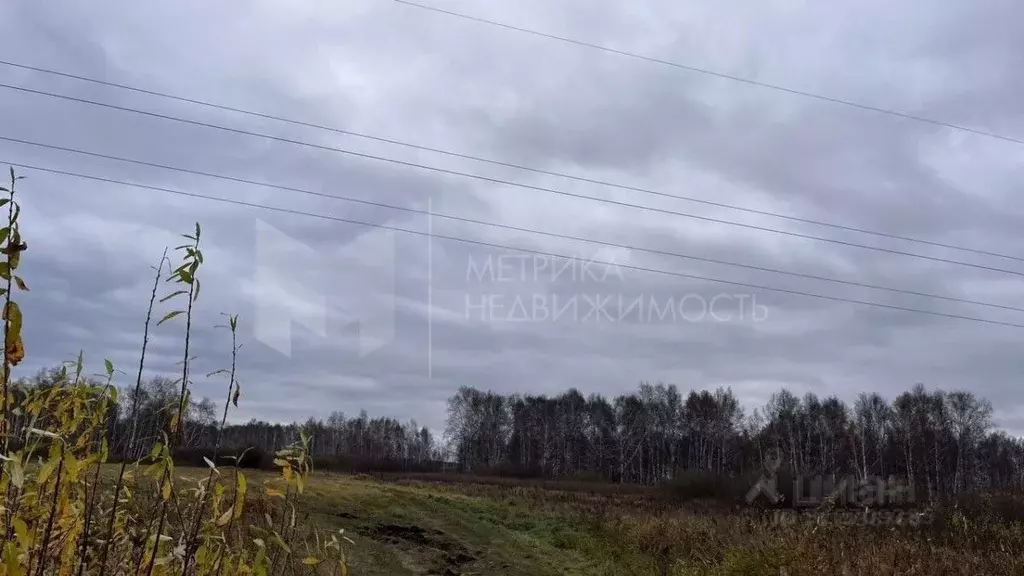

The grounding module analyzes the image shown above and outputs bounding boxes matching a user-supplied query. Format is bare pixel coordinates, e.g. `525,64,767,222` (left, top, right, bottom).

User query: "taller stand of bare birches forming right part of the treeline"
446,383,1024,498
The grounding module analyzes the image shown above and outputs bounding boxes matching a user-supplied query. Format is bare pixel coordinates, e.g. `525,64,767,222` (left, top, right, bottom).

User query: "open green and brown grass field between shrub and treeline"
149,468,1024,576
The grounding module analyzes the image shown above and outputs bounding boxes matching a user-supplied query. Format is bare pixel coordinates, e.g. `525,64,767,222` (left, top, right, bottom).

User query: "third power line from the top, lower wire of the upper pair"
0,83,1024,277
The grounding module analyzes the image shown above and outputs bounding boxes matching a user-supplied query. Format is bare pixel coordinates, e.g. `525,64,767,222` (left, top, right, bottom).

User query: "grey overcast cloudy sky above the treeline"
0,0,1024,434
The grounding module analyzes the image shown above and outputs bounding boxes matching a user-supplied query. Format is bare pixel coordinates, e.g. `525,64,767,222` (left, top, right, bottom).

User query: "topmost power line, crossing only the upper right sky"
393,0,1024,145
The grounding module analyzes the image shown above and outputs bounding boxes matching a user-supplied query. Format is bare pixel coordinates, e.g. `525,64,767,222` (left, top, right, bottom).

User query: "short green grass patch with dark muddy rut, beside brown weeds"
234,467,617,576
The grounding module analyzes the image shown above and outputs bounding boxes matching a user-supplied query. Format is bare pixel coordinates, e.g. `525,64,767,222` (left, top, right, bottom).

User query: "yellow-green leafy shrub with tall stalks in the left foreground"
0,169,347,575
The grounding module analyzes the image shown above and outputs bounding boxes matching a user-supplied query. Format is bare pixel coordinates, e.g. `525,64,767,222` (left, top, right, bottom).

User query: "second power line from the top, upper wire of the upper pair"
0,59,1024,261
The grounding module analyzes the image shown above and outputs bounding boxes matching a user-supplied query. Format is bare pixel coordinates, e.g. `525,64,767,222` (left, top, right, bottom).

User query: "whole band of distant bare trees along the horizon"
17,369,1024,499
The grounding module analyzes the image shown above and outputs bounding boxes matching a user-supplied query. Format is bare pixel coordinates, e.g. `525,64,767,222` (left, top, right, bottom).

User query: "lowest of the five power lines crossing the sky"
8,160,1024,328
